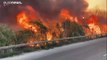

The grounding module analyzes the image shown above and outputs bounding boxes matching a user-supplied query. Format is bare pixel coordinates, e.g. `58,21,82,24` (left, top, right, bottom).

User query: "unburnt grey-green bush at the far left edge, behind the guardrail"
0,24,17,46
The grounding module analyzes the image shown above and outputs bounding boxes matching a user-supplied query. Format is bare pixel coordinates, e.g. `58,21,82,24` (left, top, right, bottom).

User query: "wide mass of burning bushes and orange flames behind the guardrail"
17,6,106,46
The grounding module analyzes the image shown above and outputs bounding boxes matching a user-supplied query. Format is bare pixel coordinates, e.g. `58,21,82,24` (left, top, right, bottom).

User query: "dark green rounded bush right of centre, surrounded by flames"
62,20,85,37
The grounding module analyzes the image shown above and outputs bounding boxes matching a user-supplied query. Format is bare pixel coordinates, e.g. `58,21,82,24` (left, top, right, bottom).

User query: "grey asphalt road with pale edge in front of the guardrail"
0,38,107,60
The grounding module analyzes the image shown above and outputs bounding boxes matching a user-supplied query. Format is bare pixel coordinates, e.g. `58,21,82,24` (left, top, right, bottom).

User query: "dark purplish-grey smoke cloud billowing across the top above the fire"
0,0,88,29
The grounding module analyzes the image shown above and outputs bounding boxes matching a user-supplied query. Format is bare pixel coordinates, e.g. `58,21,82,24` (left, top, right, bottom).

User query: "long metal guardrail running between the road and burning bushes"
0,34,106,50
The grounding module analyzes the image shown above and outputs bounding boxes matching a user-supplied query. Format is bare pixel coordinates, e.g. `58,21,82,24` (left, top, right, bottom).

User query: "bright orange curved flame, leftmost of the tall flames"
17,12,37,32
